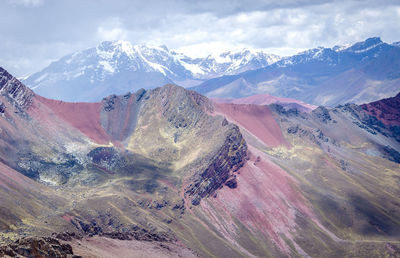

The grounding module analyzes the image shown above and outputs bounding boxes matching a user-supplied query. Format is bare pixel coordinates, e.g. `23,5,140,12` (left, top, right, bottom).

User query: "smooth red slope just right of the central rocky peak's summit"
214,102,288,147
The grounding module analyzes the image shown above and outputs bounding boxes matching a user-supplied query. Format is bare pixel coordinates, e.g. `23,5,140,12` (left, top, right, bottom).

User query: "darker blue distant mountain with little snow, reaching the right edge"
191,38,400,106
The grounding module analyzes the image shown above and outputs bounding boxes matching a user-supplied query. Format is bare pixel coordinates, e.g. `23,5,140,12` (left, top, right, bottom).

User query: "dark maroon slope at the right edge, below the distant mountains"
361,93,400,125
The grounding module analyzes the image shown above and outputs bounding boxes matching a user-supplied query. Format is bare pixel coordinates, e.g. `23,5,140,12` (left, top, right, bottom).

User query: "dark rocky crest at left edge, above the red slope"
0,67,34,110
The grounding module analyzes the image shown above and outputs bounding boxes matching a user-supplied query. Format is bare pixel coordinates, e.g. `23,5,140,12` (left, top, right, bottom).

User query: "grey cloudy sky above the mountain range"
0,0,400,77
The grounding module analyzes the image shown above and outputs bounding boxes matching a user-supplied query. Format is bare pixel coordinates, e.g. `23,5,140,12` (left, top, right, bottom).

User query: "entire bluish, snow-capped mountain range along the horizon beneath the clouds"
23,38,400,106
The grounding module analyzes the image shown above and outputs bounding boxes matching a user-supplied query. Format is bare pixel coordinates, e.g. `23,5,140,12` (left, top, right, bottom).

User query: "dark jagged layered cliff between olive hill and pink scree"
185,126,247,205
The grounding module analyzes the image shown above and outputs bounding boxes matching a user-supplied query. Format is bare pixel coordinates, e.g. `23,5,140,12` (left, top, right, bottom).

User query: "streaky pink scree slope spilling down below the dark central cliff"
201,146,316,253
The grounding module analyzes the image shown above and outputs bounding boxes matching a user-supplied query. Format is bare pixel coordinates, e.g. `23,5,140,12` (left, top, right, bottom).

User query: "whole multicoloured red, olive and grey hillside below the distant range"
0,69,400,257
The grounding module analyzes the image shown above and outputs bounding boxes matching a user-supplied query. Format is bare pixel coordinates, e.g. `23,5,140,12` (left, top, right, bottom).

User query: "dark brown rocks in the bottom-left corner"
0,237,80,258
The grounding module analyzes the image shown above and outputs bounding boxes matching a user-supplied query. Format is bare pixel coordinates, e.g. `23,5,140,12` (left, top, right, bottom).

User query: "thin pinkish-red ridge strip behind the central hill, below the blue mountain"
214,94,317,112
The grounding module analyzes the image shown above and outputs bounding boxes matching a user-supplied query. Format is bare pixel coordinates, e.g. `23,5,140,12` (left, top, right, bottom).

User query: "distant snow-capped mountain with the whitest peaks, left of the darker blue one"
23,40,279,102
